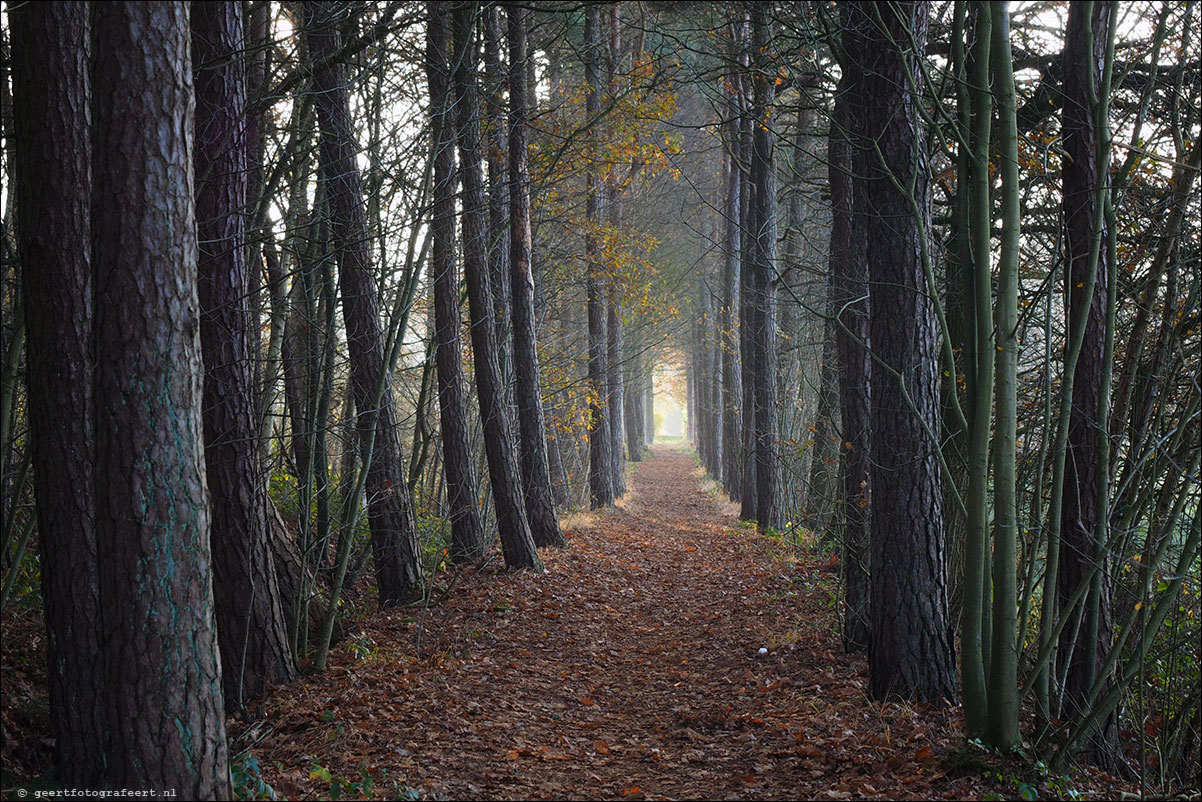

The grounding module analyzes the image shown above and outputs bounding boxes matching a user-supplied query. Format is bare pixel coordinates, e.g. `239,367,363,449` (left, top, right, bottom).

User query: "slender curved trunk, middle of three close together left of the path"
451,2,542,570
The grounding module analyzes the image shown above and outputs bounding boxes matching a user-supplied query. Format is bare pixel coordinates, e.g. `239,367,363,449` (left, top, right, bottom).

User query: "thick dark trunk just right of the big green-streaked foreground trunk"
191,2,293,711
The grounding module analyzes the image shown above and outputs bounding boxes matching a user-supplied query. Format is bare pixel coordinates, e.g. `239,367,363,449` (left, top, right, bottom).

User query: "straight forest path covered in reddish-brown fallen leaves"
246,445,983,800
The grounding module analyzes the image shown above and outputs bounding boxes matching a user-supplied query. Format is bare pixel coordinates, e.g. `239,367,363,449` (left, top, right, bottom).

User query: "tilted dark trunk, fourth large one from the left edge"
304,0,422,605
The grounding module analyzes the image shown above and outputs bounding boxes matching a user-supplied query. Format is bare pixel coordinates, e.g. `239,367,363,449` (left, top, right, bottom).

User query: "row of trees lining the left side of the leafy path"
2,0,677,798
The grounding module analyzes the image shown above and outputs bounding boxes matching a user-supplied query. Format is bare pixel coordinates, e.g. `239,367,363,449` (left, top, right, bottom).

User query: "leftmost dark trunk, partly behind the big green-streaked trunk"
8,2,107,788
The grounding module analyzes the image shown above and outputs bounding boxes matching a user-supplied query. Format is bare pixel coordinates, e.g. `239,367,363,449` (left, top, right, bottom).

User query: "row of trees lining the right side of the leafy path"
690,1,1200,777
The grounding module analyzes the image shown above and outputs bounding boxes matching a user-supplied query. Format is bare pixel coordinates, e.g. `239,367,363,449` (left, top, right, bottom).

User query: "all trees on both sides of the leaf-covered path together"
0,0,1202,798
